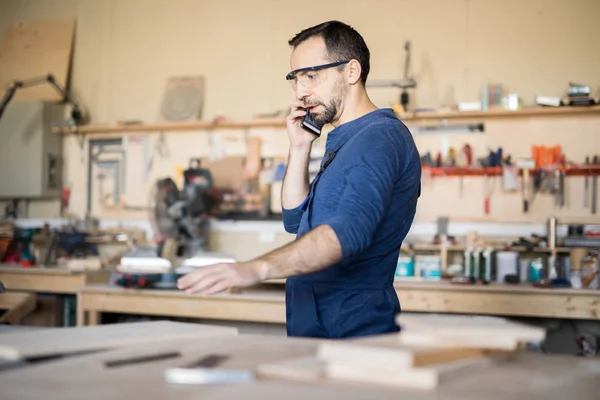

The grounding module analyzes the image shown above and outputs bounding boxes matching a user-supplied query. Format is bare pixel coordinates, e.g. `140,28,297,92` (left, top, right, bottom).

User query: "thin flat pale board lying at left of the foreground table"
0,321,237,359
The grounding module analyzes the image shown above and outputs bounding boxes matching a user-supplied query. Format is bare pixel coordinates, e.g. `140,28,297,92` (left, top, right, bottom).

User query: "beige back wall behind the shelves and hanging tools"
0,0,600,225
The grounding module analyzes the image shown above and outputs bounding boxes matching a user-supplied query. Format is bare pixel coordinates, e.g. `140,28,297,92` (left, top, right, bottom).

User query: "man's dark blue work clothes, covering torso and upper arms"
283,109,421,337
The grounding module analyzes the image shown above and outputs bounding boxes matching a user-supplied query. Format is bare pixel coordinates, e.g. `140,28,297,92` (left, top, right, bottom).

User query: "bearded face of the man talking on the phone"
290,38,349,127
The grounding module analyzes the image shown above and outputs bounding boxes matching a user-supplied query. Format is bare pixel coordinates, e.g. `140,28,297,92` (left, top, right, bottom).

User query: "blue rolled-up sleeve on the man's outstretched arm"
323,146,399,259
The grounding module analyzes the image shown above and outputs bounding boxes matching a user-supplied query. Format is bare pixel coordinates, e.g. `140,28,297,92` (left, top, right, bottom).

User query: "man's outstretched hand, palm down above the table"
177,262,266,296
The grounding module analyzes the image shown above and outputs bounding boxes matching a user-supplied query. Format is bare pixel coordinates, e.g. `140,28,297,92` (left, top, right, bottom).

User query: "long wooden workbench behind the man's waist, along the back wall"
77,281,600,325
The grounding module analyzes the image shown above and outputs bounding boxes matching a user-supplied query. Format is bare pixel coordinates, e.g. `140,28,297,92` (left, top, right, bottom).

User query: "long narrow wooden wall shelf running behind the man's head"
52,106,600,136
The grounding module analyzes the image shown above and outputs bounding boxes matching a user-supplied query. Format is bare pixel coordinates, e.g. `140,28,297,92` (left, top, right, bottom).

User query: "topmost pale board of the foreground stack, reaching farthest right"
396,314,546,350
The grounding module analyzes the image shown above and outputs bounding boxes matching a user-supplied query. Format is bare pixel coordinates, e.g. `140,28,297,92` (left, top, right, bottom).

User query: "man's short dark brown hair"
288,21,371,85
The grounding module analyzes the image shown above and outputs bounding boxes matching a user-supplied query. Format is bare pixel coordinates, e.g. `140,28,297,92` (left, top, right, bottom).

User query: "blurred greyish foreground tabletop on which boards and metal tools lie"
0,328,600,400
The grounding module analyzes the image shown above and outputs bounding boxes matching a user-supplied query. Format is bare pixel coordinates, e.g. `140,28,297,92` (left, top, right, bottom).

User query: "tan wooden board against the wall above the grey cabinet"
0,19,75,101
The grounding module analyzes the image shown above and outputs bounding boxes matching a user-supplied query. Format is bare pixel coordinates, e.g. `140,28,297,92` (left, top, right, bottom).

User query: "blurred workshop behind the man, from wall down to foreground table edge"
0,0,600,355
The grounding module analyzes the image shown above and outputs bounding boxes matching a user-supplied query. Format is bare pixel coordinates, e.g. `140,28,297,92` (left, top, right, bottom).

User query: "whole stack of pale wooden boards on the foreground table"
318,315,545,389
